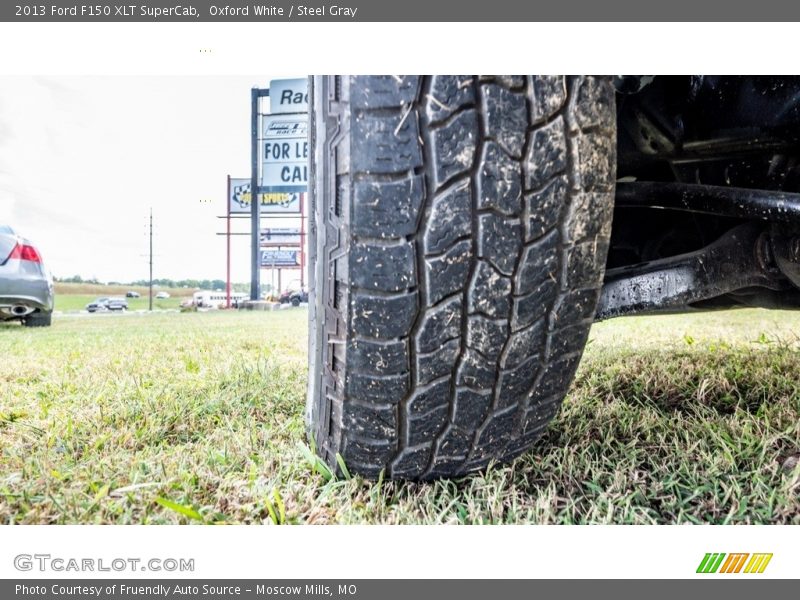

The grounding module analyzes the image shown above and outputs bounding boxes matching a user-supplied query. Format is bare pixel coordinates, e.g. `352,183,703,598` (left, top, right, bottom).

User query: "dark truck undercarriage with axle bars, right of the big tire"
597,76,800,320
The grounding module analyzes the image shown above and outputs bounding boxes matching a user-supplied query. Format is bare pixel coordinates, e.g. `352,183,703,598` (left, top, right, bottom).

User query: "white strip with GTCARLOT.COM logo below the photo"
0,525,800,579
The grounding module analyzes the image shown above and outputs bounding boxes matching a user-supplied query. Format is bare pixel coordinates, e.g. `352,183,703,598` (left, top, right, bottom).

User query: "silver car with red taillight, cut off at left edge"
0,224,54,327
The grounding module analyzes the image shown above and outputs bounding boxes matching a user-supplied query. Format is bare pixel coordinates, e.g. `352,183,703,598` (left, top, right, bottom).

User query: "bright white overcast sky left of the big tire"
0,76,304,281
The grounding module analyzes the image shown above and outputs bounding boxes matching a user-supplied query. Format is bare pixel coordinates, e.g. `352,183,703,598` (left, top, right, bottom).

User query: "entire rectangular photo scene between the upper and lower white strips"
0,73,800,524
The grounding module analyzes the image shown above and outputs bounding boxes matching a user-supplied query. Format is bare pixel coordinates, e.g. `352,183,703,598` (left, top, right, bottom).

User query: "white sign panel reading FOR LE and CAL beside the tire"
261,115,308,192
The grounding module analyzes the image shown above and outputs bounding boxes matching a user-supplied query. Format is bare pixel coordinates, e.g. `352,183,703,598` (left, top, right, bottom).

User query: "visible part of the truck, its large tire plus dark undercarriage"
306,75,800,479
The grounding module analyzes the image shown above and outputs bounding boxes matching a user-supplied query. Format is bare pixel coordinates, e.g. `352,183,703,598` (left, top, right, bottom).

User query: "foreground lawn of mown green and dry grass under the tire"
0,310,800,524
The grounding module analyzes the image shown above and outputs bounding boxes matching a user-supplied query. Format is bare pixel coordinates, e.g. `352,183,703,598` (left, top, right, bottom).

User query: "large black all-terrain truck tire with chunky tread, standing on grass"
307,76,616,479
